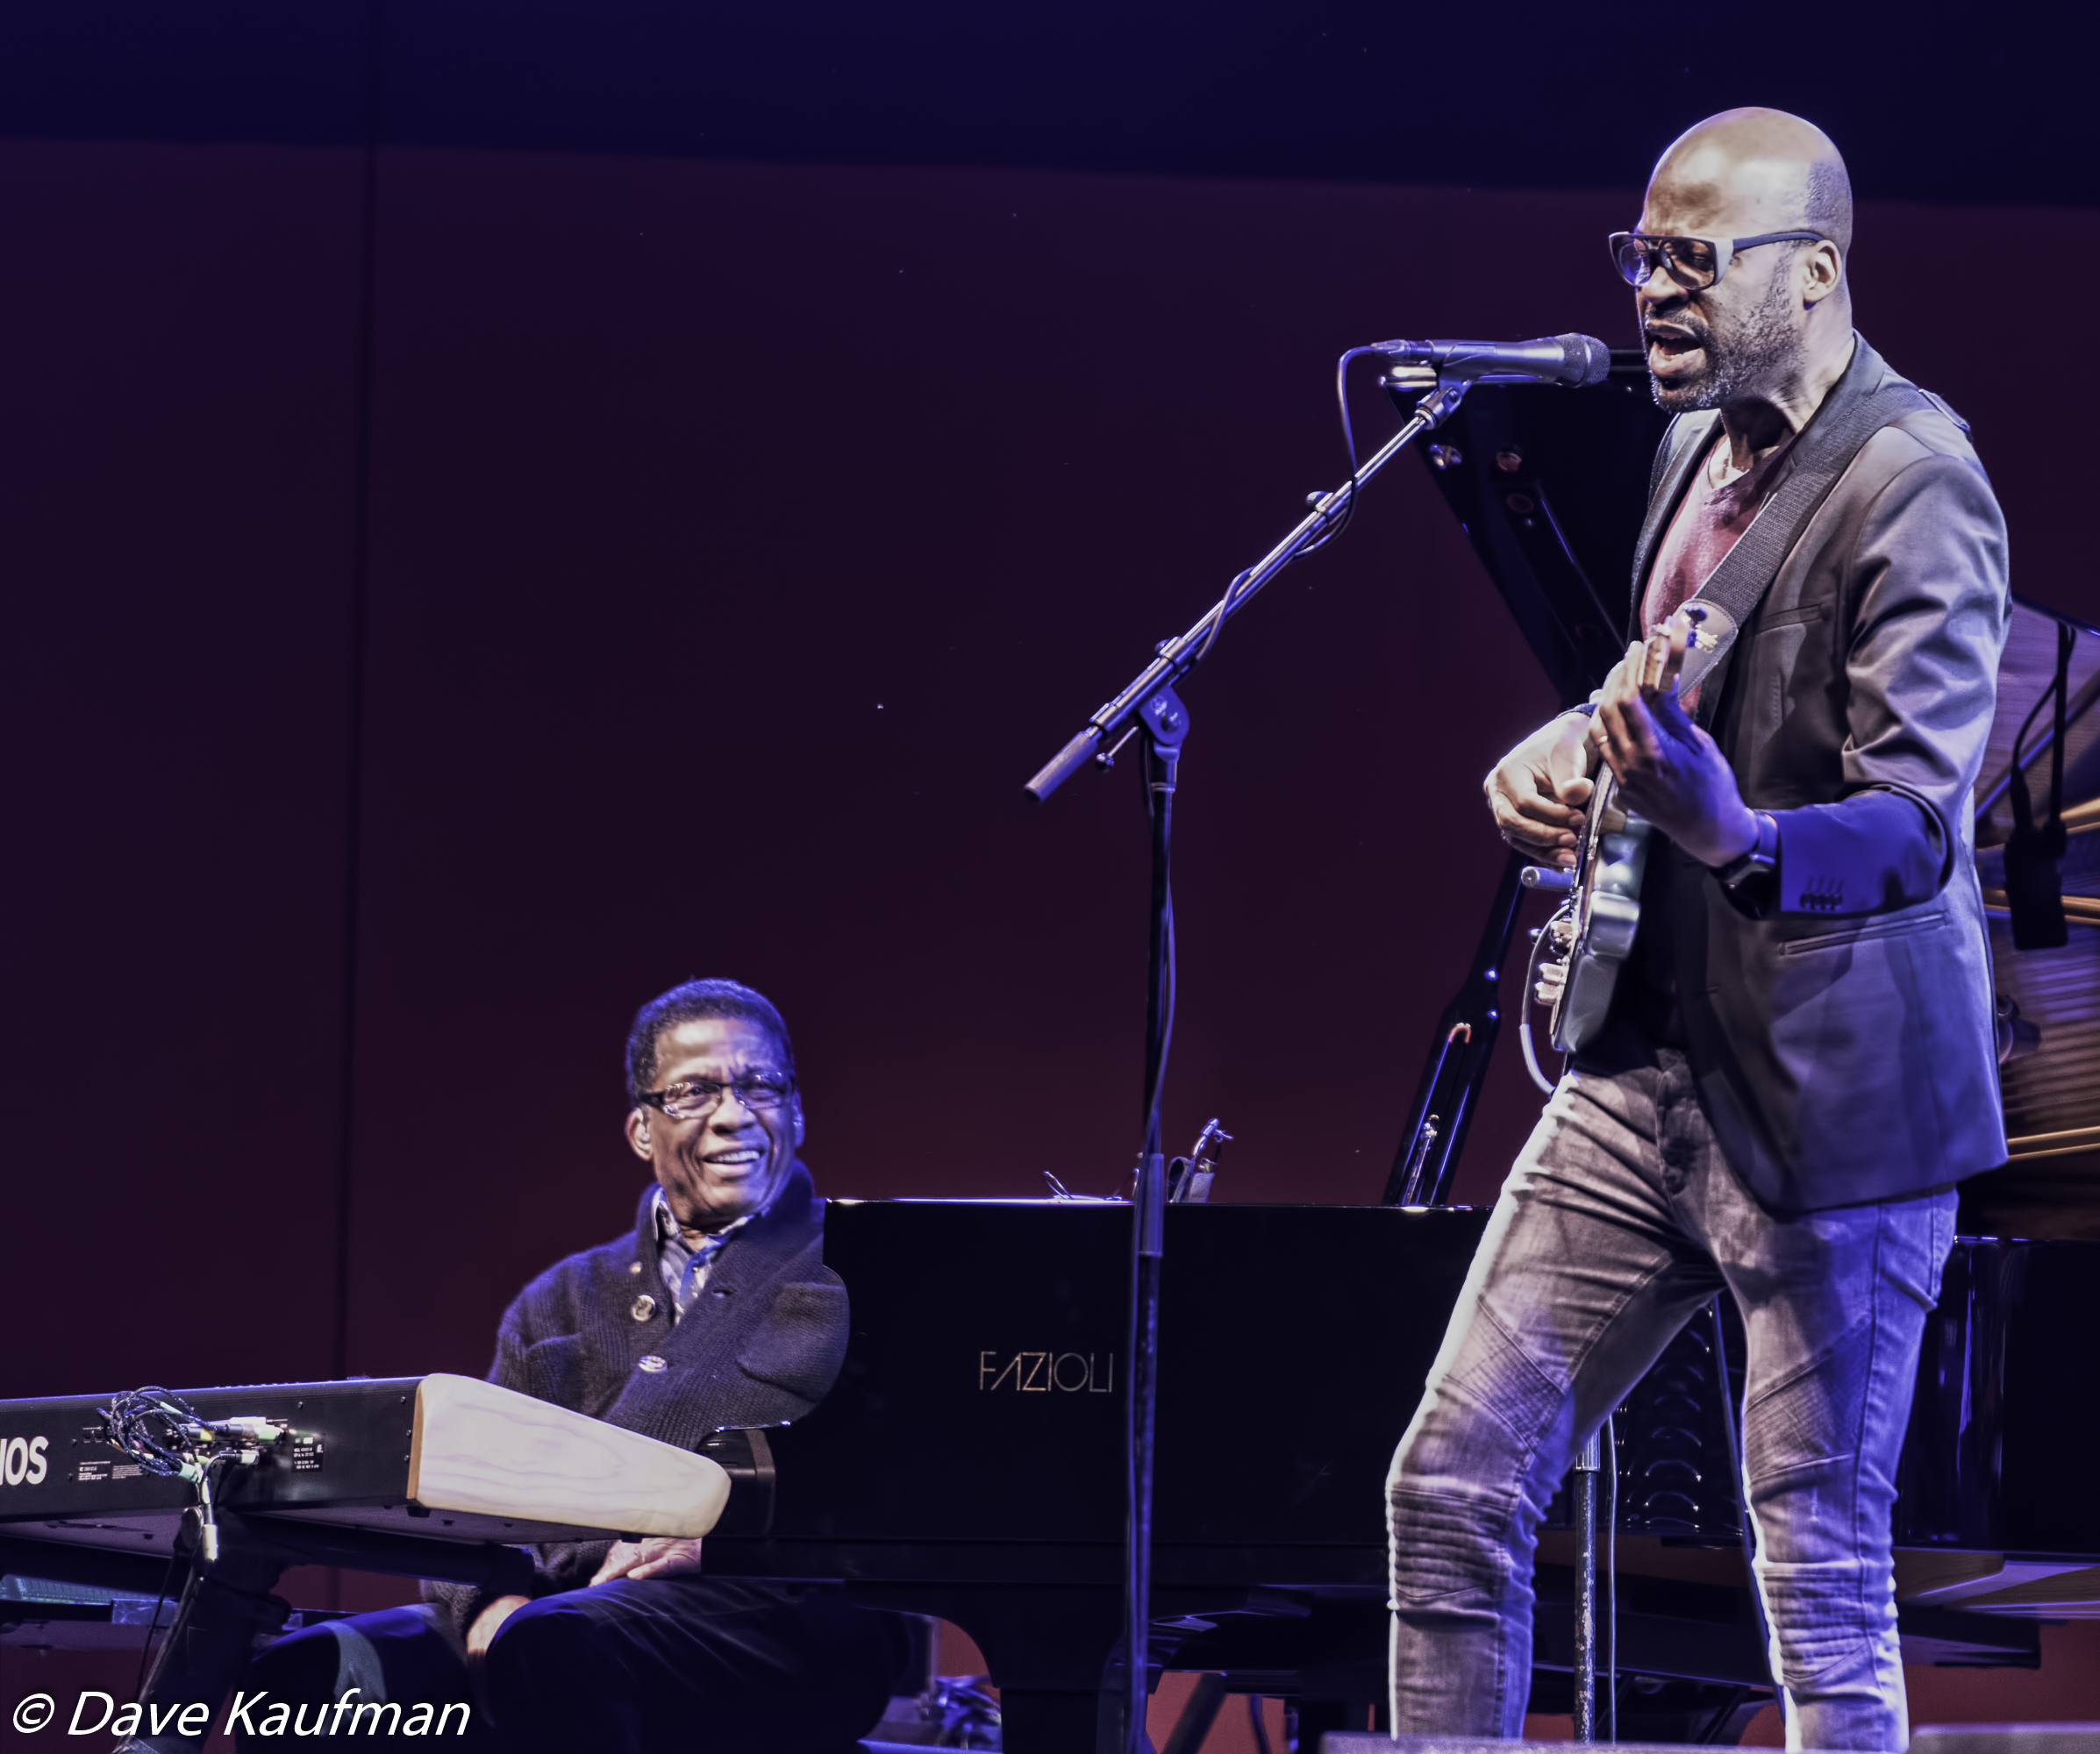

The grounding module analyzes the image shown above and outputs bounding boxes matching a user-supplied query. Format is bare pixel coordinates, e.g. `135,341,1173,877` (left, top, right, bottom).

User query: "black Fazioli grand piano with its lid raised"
0,355,2100,1754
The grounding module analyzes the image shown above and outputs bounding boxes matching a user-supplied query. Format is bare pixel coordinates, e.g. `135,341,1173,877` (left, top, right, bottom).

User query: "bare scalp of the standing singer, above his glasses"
1642,110,1853,252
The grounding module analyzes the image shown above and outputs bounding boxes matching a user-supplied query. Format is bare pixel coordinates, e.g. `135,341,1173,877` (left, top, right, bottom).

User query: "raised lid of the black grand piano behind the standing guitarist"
1395,365,2100,1239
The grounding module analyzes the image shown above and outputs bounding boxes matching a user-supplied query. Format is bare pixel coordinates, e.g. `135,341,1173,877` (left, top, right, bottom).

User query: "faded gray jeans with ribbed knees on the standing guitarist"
1388,1051,1955,1750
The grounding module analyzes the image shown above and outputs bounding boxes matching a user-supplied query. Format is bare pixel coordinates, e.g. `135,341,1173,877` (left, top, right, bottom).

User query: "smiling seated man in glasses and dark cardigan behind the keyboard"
244,981,907,1754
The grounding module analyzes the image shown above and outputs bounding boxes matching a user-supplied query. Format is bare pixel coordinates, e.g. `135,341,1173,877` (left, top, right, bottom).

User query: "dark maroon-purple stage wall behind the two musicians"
0,145,2100,1394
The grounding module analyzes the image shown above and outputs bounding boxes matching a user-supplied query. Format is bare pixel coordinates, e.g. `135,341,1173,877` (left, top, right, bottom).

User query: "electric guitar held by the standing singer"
1537,601,1734,1054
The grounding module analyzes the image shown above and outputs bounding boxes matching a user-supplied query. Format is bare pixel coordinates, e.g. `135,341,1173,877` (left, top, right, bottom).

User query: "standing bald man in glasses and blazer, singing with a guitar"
1390,110,2010,1750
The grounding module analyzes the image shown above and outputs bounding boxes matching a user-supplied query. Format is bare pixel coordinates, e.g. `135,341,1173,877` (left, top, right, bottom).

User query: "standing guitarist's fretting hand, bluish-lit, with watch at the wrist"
1589,645,1758,866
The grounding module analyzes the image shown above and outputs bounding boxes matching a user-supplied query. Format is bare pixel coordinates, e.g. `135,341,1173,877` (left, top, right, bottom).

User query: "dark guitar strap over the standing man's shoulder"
1634,340,1932,729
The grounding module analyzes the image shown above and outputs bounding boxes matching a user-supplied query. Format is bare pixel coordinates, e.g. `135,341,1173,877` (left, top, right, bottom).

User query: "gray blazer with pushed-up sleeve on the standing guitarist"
1634,340,2010,1212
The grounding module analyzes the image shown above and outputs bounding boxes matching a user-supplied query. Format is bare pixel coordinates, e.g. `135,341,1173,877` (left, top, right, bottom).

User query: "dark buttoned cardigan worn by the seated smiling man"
422,1164,848,1634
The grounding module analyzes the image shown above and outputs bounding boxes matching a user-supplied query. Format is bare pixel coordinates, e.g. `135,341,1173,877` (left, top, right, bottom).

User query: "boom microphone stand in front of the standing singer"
1027,366,1472,1754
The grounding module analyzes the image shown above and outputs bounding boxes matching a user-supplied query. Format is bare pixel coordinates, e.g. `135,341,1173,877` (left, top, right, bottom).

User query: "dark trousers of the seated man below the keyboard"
235,1578,910,1754
